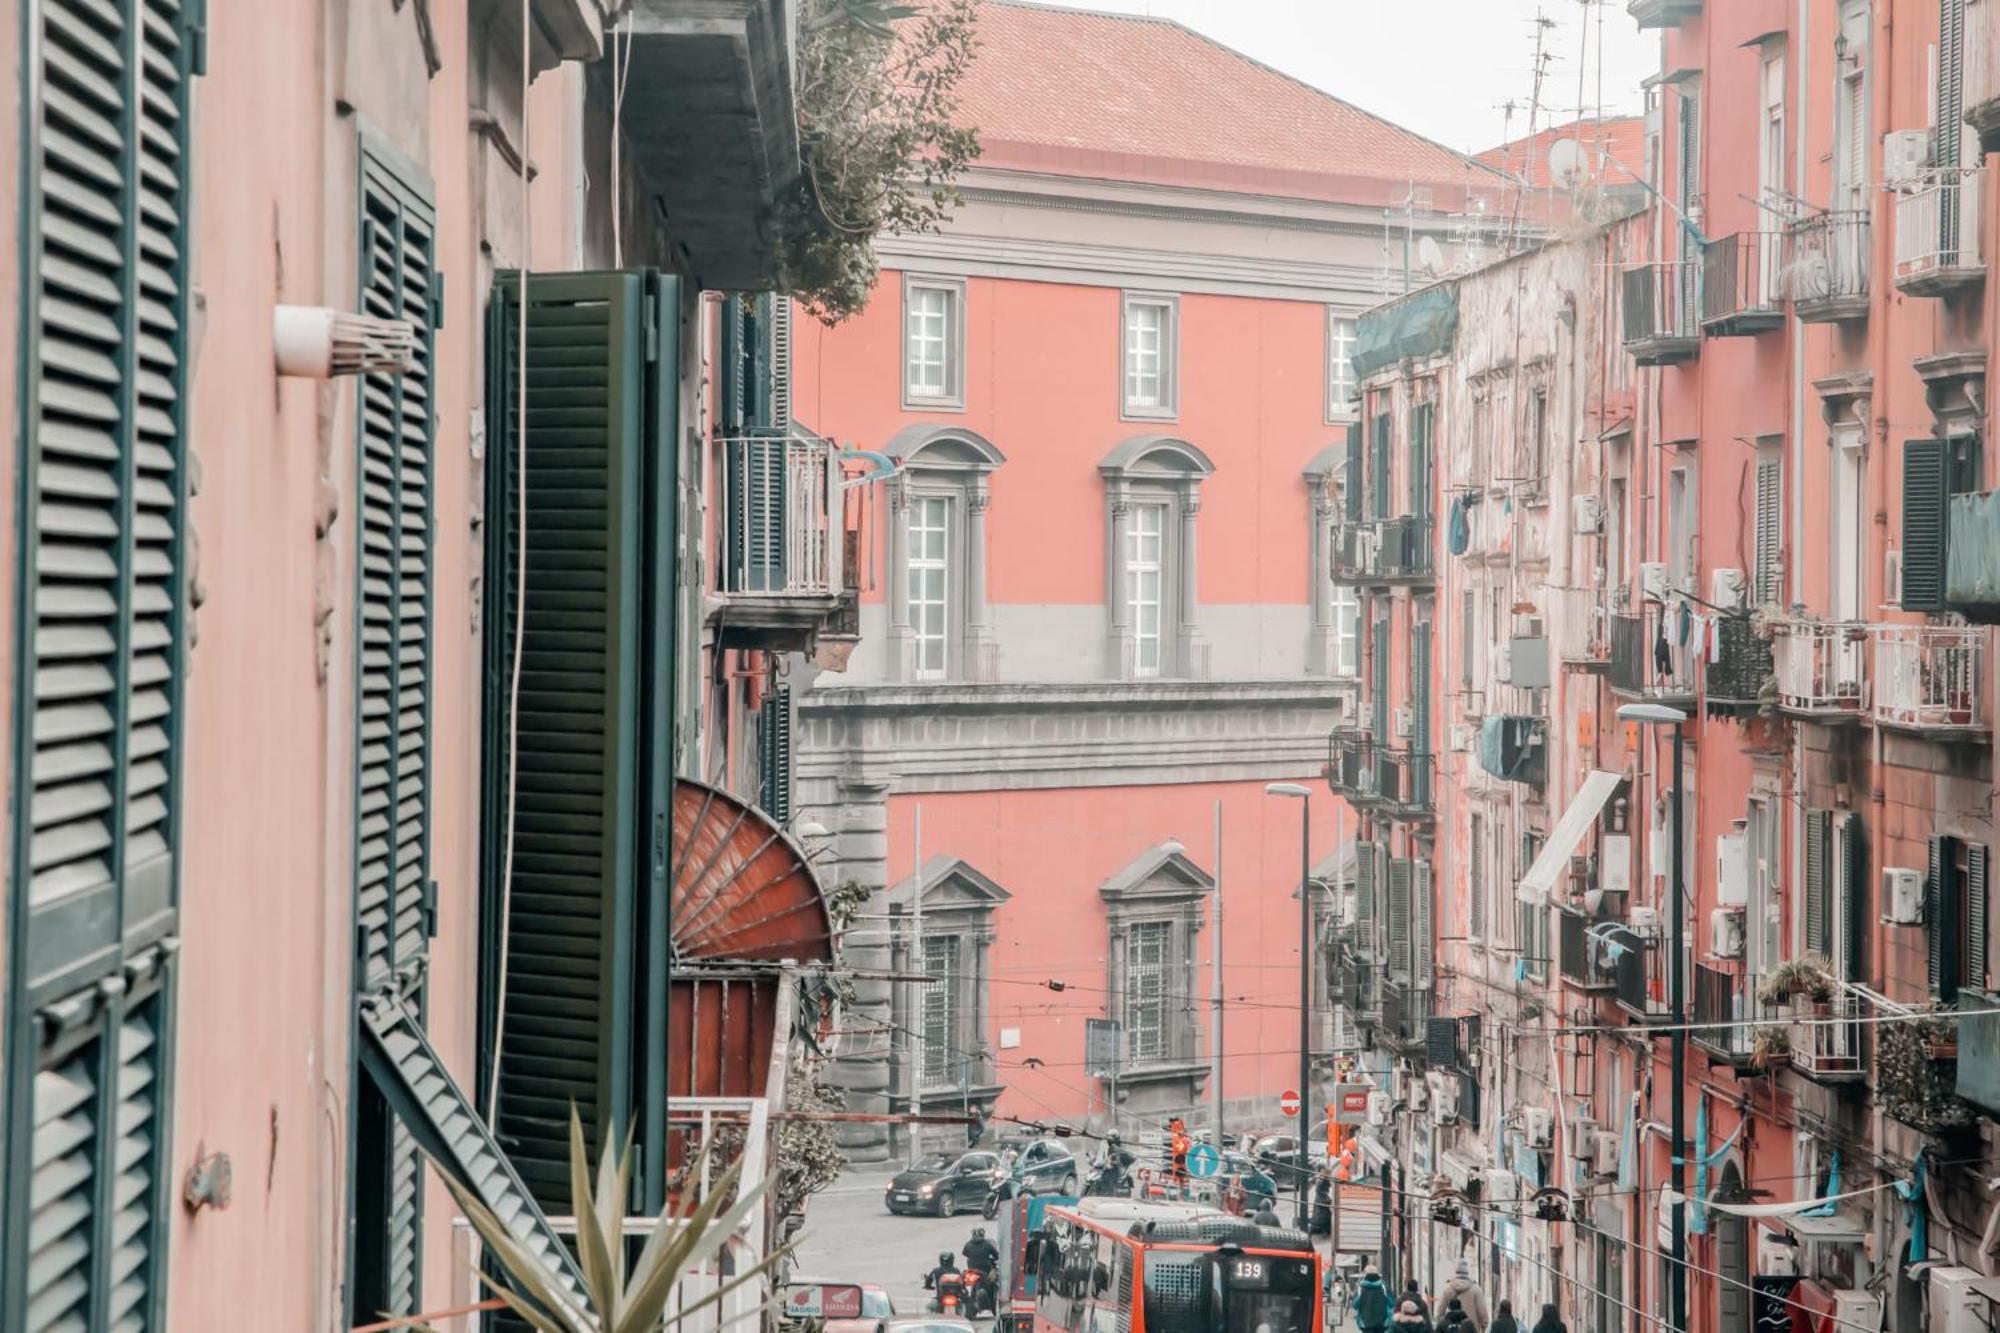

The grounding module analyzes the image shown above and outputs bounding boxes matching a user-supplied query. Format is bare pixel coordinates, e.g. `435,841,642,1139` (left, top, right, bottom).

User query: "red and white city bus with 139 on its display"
1030,1199,1322,1333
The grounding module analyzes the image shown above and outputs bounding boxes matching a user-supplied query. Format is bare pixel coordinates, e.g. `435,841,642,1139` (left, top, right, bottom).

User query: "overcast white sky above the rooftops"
1052,0,1660,152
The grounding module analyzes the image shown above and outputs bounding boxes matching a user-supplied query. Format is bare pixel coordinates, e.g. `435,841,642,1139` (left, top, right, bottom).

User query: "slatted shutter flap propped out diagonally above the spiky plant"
360,997,584,1305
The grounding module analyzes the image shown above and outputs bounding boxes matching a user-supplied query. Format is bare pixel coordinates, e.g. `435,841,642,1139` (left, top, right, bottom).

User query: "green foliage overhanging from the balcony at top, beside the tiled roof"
780,0,980,324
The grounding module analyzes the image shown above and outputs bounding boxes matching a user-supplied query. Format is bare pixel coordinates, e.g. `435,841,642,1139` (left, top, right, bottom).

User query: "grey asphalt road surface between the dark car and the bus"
792,1167,996,1315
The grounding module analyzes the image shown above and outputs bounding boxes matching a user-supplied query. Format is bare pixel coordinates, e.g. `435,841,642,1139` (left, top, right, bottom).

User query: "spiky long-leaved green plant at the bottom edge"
412,1107,786,1333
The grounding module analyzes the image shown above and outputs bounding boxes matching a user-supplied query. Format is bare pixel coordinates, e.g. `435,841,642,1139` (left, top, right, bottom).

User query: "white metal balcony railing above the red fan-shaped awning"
722,434,842,596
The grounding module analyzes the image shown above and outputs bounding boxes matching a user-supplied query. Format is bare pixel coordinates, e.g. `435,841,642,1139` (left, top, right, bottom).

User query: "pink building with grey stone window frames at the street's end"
794,0,1502,1151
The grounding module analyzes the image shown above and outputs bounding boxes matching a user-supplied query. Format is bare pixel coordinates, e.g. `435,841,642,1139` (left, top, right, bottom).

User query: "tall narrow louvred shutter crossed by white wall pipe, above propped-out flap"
354,150,436,991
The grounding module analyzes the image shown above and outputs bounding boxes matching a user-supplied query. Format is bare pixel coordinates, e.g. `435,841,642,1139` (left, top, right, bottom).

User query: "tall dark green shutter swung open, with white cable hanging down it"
482,272,678,1211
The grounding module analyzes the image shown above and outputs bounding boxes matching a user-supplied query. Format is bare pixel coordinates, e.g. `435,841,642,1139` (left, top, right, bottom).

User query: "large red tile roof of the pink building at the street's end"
960,0,1502,208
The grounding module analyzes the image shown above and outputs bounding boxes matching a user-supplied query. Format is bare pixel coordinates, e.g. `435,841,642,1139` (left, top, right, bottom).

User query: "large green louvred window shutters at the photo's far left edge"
0,0,196,1333
